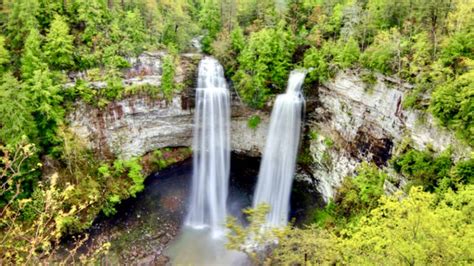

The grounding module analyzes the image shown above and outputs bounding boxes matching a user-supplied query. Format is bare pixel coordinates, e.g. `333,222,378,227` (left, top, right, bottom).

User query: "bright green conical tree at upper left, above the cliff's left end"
44,15,74,69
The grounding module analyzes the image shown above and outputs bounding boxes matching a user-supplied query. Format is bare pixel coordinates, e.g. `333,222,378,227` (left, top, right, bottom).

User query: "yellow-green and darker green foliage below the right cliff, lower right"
228,153,474,265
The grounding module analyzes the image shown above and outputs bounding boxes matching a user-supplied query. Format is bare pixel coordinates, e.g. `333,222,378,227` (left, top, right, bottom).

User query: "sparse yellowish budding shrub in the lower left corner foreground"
0,143,110,265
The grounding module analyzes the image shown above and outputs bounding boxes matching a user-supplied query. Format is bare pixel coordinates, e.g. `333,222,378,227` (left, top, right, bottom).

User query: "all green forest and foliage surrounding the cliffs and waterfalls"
0,0,474,265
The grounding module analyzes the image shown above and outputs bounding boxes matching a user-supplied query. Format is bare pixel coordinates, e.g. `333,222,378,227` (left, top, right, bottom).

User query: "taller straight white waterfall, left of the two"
186,57,230,236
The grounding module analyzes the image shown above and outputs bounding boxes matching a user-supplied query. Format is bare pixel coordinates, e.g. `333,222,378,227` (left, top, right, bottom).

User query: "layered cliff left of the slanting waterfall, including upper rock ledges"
68,53,268,158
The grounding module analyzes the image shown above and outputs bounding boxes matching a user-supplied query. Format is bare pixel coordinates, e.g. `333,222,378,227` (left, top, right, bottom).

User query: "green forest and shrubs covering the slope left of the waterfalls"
0,0,201,264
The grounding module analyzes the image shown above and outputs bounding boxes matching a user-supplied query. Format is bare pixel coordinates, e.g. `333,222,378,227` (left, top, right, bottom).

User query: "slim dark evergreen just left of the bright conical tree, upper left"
21,29,46,80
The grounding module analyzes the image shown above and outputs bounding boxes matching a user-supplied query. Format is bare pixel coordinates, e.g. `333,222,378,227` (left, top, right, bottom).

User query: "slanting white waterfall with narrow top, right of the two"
253,71,306,227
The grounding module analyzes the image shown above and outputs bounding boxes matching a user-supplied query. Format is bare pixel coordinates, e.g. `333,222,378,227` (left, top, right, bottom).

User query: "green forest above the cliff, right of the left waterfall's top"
206,0,474,145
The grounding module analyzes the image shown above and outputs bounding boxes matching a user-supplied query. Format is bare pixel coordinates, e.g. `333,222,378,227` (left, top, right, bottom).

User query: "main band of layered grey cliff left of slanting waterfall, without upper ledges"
69,96,269,158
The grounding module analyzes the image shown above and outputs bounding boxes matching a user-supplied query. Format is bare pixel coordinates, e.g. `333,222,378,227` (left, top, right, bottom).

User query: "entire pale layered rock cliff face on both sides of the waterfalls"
68,53,470,203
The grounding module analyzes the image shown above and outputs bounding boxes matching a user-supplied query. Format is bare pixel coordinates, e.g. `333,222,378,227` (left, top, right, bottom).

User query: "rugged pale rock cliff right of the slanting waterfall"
308,72,470,200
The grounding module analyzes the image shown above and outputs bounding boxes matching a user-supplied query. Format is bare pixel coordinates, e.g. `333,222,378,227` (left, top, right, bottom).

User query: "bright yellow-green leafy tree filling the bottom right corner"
341,186,474,265
